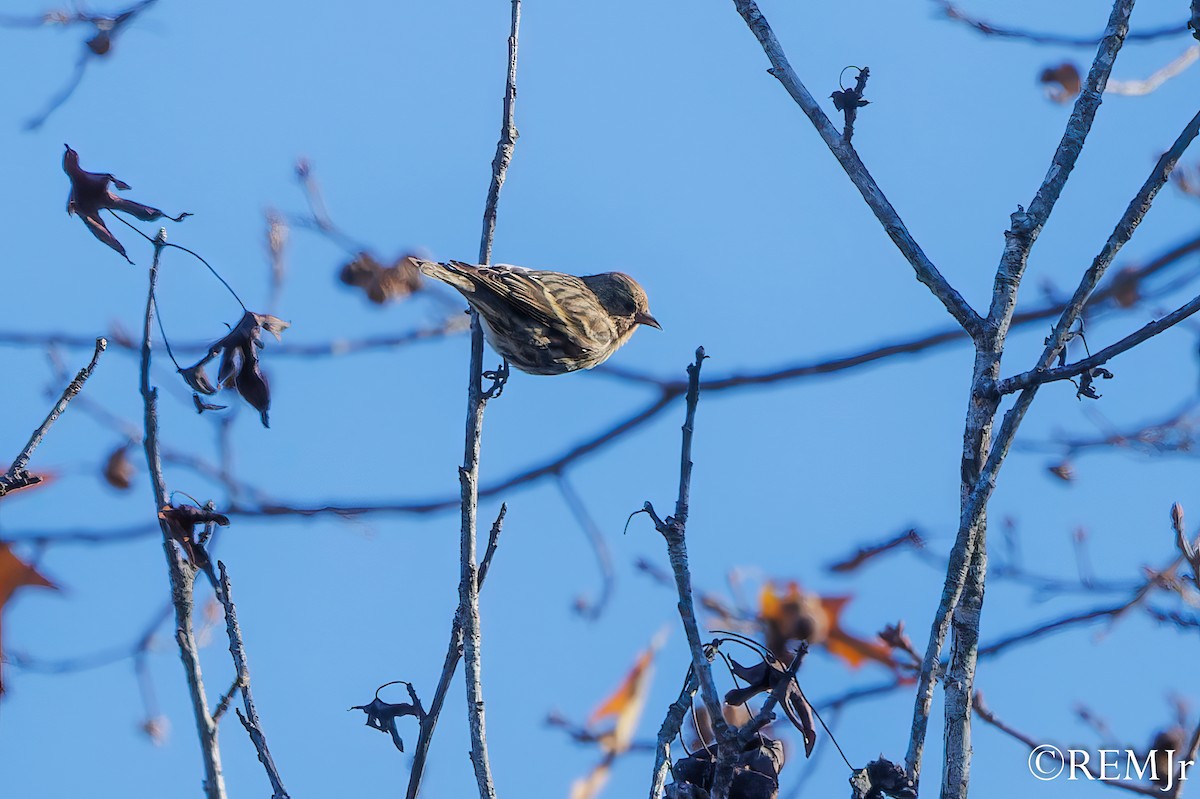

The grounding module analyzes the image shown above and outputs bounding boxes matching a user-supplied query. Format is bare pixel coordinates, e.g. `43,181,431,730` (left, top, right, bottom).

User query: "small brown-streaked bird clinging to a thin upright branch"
416,260,662,374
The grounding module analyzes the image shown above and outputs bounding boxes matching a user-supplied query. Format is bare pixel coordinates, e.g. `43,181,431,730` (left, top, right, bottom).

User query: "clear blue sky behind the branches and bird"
0,0,1200,797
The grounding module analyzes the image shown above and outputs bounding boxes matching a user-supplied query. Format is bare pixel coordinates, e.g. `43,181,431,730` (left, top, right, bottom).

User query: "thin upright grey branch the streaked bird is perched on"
457,0,521,799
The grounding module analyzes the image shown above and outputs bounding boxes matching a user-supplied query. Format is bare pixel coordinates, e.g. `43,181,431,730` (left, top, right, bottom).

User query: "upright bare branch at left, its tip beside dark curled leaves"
140,230,226,799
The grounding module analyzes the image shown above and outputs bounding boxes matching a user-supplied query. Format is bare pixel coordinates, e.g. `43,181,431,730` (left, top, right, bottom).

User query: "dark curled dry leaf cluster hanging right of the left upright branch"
179,311,290,427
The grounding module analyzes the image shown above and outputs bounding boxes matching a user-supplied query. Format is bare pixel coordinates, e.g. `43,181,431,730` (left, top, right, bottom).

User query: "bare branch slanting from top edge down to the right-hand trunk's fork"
733,0,983,338
